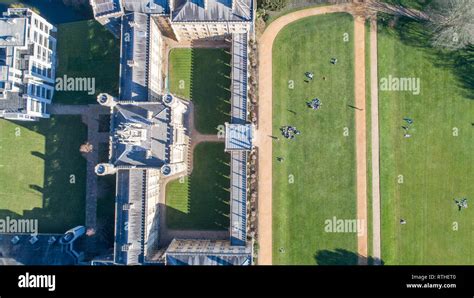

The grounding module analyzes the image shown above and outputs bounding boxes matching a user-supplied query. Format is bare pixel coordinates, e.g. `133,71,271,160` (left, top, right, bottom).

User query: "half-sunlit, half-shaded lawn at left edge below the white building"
0,116,87,233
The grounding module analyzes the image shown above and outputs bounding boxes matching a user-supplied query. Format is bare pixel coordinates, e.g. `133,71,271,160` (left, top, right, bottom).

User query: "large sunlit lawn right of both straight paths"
378,22,474,264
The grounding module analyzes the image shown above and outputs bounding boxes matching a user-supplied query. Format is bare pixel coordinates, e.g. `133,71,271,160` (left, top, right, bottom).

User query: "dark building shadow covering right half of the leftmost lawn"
0,116,87,233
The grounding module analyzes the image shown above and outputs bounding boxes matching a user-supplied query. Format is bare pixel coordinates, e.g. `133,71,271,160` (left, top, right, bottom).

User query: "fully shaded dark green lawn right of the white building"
53,20,120,104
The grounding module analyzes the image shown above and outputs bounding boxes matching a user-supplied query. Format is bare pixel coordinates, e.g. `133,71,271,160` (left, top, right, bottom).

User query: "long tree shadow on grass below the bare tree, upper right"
378,14,474,100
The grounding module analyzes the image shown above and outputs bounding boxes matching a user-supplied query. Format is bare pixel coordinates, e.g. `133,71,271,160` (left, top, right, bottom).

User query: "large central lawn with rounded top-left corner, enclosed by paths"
273,14,363,264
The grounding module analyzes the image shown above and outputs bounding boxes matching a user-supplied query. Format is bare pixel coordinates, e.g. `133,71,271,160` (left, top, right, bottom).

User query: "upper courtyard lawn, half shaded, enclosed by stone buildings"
169,48,231,134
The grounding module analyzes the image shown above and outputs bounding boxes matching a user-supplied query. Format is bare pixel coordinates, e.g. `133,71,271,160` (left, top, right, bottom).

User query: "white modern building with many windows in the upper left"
0,8,57,121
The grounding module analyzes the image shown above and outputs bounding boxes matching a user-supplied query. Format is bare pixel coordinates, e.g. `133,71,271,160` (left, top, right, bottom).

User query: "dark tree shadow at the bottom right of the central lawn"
314,248,384,265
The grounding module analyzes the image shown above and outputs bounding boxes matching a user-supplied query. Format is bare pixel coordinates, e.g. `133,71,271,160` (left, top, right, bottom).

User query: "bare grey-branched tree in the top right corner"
427,0,474,50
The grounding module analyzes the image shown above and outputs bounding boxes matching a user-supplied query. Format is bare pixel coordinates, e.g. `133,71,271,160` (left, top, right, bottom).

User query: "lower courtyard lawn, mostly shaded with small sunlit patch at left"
166,143,230,230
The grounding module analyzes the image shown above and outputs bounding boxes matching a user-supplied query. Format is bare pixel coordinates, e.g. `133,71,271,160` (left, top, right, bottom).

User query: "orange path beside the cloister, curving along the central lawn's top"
255,4,352,265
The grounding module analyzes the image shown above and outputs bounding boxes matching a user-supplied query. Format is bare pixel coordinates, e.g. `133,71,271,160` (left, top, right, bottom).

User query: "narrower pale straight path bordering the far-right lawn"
370,18,381,265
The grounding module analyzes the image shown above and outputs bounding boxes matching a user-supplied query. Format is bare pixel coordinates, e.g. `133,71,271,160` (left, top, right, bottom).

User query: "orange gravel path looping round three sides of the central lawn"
255,4,367,265
